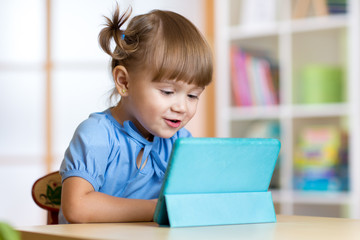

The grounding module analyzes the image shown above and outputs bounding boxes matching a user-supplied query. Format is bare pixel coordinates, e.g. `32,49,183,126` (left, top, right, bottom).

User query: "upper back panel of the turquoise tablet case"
154,138,280,225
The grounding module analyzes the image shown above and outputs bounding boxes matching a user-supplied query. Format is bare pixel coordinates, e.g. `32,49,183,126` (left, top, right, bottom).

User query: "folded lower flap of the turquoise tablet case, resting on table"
160,191,276,227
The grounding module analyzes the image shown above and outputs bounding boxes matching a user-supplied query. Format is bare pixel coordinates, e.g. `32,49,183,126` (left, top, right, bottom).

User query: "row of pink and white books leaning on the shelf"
230,46,279,106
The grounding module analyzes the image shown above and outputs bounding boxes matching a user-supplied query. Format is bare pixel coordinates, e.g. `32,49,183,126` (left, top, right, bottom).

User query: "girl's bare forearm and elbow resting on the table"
61,177,157,223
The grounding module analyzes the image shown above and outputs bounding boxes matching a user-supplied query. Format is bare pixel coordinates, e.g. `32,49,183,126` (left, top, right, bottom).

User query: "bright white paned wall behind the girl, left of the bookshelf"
0,0,204,226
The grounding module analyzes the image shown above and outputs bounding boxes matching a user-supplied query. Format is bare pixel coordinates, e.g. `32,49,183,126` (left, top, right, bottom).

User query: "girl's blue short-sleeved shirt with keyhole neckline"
60,109,191,223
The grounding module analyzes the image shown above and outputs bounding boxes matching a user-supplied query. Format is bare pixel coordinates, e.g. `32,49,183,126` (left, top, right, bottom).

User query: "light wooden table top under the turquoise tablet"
17,215,360,240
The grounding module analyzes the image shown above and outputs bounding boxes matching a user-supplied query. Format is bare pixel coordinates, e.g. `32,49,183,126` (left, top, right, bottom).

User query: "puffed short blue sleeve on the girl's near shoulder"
60,118,110,191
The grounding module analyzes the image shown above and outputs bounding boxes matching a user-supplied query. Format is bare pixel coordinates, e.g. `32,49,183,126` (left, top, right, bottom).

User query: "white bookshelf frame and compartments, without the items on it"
215,0,360,218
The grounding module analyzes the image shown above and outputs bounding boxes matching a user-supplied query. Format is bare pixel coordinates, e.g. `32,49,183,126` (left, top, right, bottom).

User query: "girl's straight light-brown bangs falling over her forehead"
148,11,212,87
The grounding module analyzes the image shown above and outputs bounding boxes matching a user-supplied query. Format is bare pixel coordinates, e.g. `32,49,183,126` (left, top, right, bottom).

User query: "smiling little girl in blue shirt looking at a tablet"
59,7,212,223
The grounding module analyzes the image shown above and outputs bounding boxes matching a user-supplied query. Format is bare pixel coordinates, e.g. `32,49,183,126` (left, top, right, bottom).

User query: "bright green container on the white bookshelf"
300,65,343,104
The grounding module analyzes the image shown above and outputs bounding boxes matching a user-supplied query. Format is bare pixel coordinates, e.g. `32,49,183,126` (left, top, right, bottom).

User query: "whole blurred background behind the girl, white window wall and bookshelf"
0,0,360,226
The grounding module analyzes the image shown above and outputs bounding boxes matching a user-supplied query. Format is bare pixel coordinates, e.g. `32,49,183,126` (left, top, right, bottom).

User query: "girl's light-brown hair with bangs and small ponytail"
99,6,213,99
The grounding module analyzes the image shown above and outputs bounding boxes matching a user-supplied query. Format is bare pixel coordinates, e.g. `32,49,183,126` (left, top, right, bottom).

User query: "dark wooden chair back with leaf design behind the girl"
31,171,61,224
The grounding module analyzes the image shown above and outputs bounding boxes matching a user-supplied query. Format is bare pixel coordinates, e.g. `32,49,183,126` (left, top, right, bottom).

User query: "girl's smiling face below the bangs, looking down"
126,71,204,138
